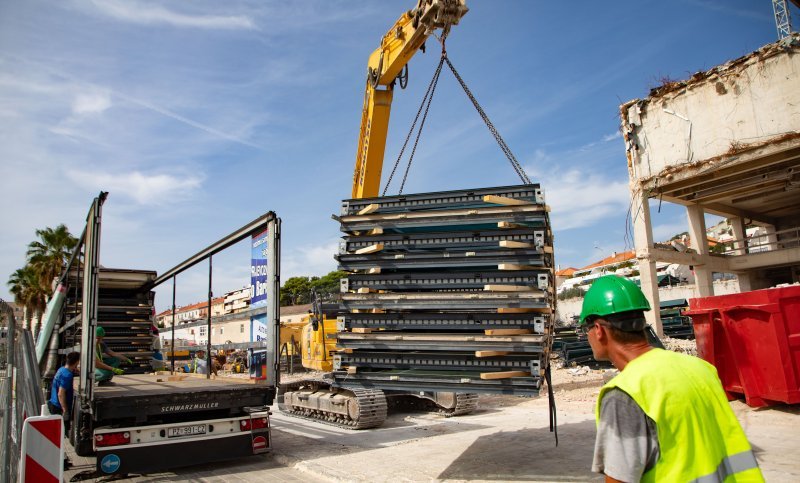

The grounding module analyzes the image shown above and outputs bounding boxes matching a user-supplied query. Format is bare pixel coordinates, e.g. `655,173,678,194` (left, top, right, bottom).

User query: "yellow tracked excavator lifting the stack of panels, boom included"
278,0,477,429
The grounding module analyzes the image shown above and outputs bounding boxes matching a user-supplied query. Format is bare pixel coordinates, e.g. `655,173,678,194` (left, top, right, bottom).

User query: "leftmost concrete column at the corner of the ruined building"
631,185,664,337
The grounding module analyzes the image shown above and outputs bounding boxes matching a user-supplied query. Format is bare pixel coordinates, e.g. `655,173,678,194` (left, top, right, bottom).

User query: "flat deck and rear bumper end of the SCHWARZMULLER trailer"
93,373,275,474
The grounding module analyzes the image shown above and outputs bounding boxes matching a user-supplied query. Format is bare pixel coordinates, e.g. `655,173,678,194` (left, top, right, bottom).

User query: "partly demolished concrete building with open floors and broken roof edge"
620,34,800,333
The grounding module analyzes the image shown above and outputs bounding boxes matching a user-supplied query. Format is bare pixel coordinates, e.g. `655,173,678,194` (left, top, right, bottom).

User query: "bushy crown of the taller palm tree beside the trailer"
28,224,78,299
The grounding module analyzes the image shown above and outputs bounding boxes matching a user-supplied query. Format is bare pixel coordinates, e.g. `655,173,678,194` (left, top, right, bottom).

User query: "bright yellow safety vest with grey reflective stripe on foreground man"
595,349,764,483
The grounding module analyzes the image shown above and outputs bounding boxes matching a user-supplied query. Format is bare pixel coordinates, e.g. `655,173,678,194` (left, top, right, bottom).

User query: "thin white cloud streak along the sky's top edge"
85,0,256,30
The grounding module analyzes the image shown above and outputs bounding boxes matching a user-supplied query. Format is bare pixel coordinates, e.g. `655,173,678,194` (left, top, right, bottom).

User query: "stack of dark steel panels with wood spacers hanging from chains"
333,184,555,395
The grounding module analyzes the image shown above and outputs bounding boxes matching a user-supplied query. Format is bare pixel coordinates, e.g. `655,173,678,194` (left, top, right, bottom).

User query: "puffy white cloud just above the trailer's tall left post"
66,170,203,205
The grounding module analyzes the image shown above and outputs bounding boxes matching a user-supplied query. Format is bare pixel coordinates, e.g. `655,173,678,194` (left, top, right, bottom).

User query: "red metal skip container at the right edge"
687,285,800,407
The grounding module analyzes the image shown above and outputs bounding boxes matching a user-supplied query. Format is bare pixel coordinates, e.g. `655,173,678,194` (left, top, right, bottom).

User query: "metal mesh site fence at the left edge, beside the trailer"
0,300,45,483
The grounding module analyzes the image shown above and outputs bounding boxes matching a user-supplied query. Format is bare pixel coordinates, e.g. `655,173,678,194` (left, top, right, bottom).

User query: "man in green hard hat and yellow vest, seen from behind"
580,275,764,482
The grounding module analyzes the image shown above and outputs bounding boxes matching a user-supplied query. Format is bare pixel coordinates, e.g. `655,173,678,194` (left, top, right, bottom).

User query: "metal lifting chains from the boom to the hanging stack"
381,36,532,196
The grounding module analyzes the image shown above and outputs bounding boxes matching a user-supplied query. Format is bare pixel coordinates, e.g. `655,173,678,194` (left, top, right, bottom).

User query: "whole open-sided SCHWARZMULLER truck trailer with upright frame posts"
53,193,280,477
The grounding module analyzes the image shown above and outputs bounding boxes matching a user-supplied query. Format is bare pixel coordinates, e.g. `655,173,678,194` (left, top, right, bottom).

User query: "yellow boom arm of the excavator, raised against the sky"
352,0,469,198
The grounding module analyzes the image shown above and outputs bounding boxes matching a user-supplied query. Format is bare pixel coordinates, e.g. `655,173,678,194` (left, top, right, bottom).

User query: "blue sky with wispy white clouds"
0,0,800,309
